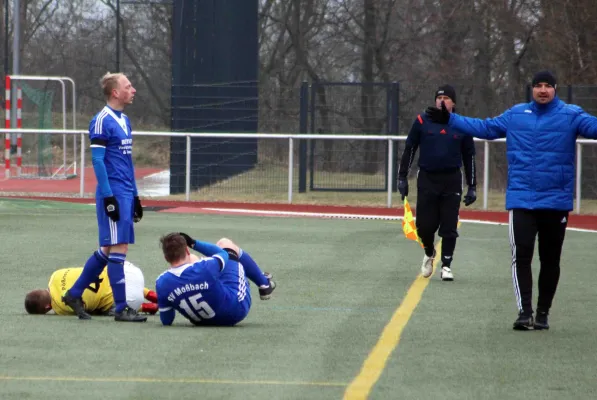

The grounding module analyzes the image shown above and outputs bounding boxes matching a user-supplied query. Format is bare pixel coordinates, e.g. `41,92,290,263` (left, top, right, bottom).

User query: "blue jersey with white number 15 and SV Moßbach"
156,255,251,325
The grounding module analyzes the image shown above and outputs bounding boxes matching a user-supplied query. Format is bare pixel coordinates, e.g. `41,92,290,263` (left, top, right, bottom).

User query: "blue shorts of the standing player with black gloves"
95,193,135,246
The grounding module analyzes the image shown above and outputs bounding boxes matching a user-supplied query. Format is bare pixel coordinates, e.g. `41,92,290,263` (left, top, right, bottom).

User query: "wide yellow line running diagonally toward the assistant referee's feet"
344,236,444,400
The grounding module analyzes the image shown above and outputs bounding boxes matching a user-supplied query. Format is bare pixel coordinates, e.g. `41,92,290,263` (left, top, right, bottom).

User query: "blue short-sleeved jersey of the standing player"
89,106,137,195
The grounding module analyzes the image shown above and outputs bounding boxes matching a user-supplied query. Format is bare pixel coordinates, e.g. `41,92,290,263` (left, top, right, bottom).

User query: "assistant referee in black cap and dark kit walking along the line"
398,85,477,281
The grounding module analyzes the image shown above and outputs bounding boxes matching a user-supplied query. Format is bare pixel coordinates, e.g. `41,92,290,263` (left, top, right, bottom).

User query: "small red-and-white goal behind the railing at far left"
4,75,80,179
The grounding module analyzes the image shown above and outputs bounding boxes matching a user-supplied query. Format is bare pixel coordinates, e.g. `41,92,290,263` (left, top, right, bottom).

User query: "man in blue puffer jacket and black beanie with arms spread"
426,71,597,330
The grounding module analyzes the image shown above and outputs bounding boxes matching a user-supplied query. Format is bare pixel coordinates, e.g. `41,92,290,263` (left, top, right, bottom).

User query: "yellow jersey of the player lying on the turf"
48,268,114,315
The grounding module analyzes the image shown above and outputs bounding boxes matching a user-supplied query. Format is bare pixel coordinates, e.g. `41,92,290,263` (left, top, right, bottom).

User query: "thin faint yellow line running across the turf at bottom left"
0,375,346,387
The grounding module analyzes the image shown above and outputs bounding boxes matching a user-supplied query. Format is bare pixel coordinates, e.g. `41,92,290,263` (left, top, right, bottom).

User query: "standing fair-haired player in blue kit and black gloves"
62,73,147,322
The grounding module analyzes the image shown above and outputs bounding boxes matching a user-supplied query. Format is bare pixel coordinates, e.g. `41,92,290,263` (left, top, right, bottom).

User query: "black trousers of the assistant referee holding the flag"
416,169,462,267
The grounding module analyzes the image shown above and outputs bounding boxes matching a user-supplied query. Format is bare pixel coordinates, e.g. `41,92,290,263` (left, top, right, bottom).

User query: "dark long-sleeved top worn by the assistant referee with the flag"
398,114,477,186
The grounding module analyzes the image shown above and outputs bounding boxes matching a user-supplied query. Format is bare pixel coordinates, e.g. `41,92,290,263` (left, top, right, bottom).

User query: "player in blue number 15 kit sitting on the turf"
156,232,276,326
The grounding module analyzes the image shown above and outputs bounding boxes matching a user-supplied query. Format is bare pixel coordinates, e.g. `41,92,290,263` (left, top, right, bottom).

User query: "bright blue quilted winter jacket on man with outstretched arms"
448,96,597,211
